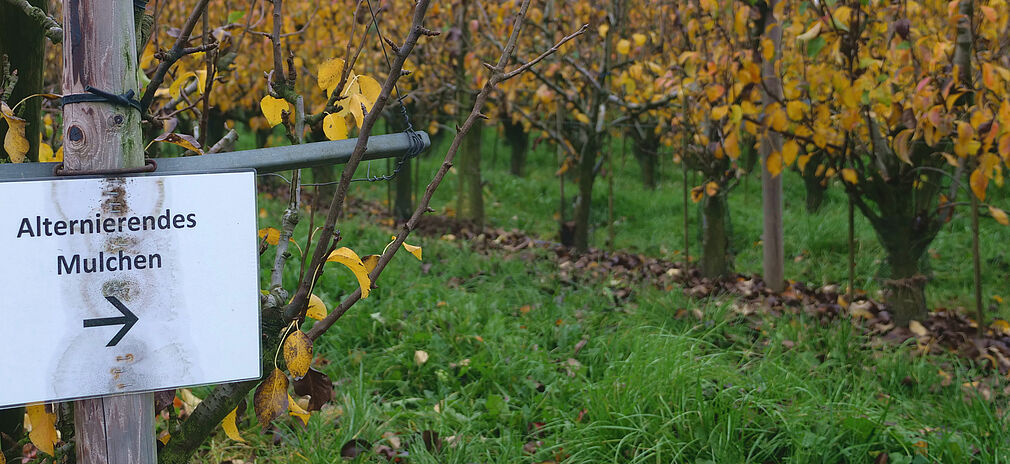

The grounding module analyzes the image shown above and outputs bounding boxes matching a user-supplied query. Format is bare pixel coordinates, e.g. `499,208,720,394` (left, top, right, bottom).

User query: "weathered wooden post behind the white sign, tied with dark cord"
63,0,157,464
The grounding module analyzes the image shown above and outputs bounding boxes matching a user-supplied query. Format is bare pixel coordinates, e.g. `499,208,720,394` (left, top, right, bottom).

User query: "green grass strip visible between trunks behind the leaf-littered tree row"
349,130,1010,317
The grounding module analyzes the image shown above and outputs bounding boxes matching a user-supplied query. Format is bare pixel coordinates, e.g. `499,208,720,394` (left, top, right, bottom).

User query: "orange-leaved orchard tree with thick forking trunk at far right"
759,0,1010,324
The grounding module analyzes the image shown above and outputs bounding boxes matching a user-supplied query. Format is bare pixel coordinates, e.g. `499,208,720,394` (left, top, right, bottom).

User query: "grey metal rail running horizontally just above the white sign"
0,131,431,180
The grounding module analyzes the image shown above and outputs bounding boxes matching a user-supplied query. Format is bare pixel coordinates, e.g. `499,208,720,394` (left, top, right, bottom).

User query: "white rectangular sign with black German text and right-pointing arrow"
0,171,260,407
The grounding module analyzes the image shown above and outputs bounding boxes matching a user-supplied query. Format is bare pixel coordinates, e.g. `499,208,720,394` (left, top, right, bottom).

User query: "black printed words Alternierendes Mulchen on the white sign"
17,209,197,275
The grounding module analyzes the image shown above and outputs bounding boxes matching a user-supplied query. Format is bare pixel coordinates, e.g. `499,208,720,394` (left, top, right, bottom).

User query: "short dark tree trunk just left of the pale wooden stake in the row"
701,194,733,279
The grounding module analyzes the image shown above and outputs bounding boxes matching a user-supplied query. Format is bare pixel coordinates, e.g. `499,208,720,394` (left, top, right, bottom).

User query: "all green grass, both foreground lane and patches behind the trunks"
190,128,1010,463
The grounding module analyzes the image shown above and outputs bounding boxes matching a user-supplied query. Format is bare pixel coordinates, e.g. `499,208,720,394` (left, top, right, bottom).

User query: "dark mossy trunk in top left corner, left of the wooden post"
0,0,48,161
